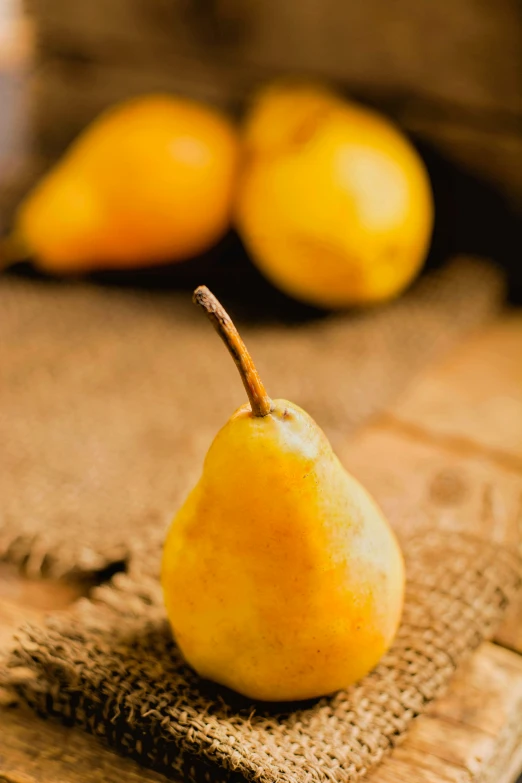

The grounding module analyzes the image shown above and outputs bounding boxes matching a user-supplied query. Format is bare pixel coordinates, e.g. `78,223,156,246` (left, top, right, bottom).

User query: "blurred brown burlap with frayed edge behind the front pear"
0,254,502,576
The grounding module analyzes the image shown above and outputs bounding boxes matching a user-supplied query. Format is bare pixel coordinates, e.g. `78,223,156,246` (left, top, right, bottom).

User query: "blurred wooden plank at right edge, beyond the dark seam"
390,311,522,466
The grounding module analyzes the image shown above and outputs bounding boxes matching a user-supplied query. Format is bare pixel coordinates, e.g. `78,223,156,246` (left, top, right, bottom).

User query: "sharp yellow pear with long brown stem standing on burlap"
162,287,405,701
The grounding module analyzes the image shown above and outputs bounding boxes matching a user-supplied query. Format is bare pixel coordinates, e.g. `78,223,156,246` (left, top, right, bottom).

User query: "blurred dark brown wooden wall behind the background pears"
21,0,522,213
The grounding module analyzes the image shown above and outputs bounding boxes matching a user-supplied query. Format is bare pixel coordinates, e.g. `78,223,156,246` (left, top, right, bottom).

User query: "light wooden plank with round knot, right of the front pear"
337,421,522,548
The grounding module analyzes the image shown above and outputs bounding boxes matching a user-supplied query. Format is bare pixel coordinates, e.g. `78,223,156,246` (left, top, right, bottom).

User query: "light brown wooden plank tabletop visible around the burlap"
0,312,522,783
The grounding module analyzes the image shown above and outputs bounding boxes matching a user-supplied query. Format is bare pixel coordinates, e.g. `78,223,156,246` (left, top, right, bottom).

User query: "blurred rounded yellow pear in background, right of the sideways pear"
236,84,433,307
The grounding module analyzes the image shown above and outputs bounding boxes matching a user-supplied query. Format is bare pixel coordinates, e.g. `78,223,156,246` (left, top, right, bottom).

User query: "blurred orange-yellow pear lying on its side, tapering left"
10,95,237,272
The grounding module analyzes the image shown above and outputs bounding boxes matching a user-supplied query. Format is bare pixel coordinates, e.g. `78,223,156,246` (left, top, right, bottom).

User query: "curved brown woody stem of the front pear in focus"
192,285,273,416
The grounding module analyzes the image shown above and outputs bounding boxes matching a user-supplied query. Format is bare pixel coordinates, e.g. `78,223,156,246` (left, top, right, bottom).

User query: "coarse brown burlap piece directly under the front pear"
7,531,522,783
